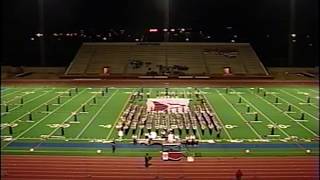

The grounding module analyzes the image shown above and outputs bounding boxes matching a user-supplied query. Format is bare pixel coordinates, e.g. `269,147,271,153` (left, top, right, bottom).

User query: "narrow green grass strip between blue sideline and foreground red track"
2,148,319,157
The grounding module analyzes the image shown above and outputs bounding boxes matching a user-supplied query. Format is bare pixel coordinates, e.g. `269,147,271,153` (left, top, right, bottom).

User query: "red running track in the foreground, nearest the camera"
1,155,319,180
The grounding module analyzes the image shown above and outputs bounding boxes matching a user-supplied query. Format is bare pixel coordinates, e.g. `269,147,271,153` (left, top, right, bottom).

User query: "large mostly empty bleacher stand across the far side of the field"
64,42,270,78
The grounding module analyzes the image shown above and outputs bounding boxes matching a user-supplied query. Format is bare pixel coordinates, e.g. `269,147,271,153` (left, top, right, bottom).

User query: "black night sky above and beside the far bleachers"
1,0,318,66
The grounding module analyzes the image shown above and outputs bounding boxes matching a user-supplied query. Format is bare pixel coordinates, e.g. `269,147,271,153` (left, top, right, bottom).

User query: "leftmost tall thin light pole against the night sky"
38,0,46,66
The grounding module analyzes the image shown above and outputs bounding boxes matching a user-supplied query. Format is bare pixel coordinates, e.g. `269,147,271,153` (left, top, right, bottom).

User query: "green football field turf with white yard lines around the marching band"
1,86,319,156
